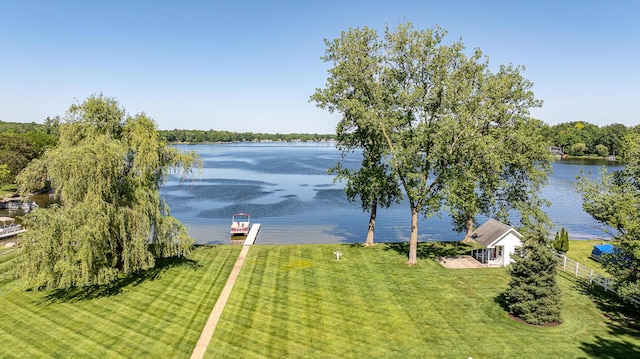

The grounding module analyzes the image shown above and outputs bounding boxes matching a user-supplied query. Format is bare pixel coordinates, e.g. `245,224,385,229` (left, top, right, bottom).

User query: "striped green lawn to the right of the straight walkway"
207,244,640,358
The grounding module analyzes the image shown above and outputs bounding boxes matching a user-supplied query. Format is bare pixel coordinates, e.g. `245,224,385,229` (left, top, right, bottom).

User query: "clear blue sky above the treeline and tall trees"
0,0,640,133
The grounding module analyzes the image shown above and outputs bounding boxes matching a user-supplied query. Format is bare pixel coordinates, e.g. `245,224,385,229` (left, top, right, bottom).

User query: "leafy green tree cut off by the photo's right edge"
577,132,640,303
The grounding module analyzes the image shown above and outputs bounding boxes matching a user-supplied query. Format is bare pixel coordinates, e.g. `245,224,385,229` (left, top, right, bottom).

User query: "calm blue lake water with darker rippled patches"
161,143,619,244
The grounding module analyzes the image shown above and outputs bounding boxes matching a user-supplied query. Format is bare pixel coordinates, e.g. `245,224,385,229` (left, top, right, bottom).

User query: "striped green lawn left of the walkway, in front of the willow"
0,246,240,358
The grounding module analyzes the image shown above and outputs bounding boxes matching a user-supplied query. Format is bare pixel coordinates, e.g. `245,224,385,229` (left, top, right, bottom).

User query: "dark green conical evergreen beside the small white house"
504,228,562,325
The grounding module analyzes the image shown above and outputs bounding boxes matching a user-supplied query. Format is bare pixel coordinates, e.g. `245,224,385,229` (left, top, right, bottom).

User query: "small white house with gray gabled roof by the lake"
471,219,522,267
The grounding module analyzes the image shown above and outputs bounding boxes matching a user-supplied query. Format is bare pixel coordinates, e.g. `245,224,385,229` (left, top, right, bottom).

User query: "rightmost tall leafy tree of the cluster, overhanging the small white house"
444,65,551,241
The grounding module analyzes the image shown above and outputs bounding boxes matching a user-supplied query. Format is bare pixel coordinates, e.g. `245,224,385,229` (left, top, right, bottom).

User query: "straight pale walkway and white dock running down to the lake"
191,223,260,359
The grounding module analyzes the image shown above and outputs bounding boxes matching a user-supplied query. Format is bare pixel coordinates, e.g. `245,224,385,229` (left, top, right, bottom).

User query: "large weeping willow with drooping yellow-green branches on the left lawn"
17,95,200,288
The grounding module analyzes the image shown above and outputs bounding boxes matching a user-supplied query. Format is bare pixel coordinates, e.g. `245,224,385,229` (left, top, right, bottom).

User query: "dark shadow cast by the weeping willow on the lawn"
38,257,201,304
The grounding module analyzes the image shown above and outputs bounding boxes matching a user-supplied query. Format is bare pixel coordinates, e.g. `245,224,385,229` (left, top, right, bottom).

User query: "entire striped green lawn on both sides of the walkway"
0,244,640,359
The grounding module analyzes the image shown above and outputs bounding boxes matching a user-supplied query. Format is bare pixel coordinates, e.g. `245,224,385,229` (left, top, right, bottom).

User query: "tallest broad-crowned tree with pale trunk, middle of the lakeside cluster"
316,23,537,264
